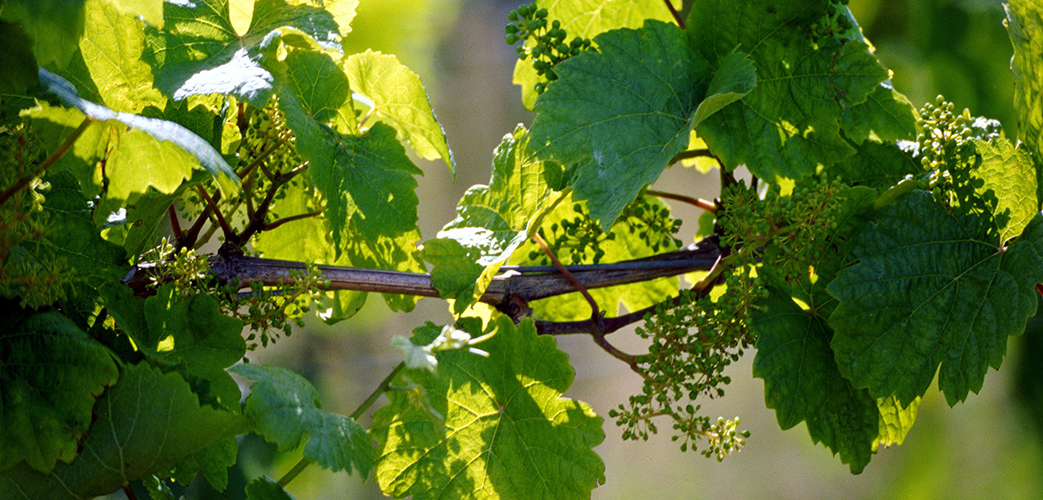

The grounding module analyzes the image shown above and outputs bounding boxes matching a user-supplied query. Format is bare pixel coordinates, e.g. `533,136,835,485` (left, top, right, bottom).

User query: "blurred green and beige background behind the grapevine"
134,0,1043,500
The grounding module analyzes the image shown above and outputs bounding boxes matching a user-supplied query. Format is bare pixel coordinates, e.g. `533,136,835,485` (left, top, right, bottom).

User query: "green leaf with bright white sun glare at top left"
145,0,354,106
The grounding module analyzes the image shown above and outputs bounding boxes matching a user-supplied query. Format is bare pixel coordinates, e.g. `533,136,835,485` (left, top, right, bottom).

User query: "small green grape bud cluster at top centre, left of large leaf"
504,3,590,94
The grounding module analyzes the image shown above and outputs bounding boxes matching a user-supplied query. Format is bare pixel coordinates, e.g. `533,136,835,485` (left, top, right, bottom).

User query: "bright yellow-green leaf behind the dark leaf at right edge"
971,137,1040,241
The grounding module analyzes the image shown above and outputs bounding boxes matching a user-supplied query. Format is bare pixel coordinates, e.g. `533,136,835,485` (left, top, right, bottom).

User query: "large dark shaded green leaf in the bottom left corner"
0,363,245,500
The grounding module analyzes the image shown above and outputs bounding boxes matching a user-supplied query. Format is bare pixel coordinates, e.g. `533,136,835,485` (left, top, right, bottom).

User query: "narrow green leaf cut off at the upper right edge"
1003,0,1043,183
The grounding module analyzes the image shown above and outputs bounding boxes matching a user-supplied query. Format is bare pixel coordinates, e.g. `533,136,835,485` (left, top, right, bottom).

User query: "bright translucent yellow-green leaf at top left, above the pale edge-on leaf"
79,0,166,113
